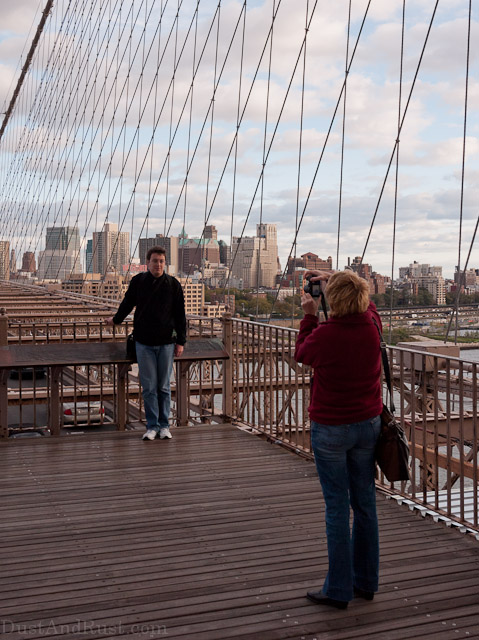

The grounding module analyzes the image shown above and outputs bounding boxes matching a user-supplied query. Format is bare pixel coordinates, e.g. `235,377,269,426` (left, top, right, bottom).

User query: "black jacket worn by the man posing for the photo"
113,271,186,346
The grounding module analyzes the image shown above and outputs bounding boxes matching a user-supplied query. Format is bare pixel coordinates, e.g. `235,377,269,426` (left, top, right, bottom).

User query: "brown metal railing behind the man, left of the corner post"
0,316,229,437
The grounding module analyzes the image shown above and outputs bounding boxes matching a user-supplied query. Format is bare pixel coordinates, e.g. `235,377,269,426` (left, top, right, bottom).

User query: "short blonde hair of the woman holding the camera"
326,270,369,316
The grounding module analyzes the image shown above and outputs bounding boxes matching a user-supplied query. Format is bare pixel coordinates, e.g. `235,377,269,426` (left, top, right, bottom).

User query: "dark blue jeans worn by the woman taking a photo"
311,416,381,602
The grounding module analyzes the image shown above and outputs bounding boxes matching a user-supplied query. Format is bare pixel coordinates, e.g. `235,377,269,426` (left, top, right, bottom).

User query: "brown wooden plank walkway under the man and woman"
0,425,479,640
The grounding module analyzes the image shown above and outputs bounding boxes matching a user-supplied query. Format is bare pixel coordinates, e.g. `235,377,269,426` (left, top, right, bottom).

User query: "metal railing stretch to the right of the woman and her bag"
390,347,479,528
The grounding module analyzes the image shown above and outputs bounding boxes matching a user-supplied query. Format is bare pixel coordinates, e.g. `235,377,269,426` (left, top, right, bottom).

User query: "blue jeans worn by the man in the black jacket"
136,342,175,433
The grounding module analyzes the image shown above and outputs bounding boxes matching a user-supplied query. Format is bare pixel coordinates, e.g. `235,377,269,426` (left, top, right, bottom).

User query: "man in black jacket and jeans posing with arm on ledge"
105,247,186,440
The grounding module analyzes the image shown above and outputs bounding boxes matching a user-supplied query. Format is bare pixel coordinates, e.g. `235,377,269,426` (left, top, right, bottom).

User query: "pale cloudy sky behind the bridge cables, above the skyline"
0,0,479,277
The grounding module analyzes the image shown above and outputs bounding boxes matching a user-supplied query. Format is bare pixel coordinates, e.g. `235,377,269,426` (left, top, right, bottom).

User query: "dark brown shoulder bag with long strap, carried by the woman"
373,318,411,482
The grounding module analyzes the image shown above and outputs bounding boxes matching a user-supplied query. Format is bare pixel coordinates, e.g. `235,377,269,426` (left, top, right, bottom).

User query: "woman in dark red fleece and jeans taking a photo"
295,271,382,609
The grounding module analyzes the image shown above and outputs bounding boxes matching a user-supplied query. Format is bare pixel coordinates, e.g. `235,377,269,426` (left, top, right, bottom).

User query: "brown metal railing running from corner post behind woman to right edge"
228,319,479,528
